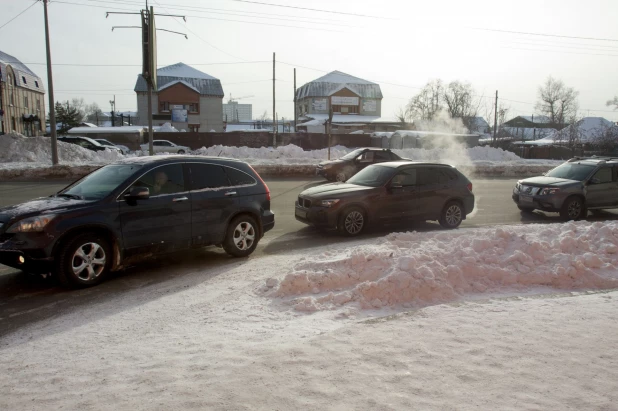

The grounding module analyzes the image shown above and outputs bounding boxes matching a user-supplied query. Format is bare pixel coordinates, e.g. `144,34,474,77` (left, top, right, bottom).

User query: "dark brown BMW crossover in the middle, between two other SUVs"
295,161,474,236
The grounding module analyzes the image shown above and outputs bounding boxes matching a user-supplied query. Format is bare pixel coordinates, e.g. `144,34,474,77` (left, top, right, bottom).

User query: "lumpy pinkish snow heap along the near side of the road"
263,222,618,311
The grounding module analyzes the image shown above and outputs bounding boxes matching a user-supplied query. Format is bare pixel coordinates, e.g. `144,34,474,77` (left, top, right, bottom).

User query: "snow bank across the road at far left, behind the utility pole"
0,133,124,165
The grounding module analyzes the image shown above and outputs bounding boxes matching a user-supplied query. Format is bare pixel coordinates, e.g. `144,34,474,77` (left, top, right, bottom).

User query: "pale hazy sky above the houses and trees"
0,0,618,121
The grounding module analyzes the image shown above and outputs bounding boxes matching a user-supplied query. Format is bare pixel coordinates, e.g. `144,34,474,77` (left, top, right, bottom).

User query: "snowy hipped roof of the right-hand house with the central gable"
297,71,382,98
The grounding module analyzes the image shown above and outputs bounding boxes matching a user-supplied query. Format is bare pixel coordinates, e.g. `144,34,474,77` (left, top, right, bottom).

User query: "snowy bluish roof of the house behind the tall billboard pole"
135,63,223,98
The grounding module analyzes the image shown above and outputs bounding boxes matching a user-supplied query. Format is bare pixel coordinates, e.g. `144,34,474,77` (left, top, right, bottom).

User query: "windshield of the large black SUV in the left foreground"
57,164,142,200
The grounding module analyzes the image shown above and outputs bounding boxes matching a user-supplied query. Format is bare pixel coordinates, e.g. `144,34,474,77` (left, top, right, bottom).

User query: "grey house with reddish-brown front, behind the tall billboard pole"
135,63,223,132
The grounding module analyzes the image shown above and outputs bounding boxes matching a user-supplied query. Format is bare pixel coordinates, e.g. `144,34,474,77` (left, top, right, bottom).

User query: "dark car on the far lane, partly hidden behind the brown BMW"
315,148,402,181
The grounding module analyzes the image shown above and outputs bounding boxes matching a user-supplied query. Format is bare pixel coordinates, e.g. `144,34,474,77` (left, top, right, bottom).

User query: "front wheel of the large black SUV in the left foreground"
56,233,113,288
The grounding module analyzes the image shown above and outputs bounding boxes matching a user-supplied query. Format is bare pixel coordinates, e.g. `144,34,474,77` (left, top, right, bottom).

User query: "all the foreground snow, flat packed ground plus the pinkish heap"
0,222,618,410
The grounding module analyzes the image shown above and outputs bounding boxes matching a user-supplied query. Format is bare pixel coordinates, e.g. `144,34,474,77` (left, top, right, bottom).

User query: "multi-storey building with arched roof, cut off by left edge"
0,51,45,136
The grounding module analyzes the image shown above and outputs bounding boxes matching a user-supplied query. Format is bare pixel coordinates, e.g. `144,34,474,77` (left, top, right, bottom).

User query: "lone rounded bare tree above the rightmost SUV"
536,76,579,129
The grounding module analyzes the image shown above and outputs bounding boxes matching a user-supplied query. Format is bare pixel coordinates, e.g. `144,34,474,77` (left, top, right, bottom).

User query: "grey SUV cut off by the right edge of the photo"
512,157,618,220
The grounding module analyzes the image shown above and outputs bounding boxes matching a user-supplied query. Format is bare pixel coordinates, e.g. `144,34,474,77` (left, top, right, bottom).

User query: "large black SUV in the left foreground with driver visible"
0,155,275,287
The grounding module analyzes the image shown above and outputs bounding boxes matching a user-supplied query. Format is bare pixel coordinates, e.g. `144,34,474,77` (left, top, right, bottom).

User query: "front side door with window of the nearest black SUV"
119,164,191,251
